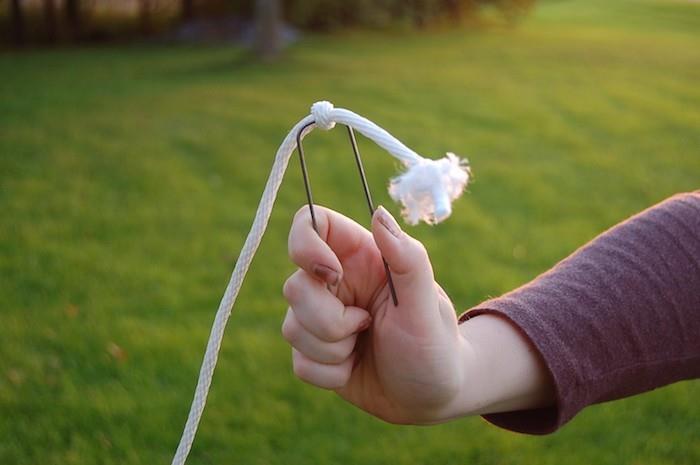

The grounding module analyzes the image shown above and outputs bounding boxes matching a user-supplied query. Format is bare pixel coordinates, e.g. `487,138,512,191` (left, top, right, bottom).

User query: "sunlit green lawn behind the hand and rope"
0,0,700,465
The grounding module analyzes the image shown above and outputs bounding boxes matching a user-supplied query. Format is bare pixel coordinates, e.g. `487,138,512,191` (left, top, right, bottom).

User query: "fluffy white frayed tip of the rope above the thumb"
389,153,471,225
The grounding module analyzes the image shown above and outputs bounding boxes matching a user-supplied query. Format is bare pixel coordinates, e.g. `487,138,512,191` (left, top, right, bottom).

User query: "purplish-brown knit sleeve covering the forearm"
460,191,700,434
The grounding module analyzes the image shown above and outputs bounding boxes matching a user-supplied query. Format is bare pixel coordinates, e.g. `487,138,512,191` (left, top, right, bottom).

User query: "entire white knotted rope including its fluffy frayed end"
172,101,470,465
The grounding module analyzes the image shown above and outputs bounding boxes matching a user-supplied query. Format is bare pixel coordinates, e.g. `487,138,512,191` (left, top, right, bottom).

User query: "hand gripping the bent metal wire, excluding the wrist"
282,207,470,423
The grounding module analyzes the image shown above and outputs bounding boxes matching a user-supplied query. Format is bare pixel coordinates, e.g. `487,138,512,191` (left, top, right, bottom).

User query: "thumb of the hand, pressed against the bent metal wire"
372,206,438,322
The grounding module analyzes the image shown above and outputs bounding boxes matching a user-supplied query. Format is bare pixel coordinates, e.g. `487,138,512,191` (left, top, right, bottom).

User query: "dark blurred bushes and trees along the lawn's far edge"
0,0,535,45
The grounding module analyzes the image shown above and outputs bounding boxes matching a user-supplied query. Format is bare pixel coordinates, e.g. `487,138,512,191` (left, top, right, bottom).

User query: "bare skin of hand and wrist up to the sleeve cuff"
282,206,555,424
